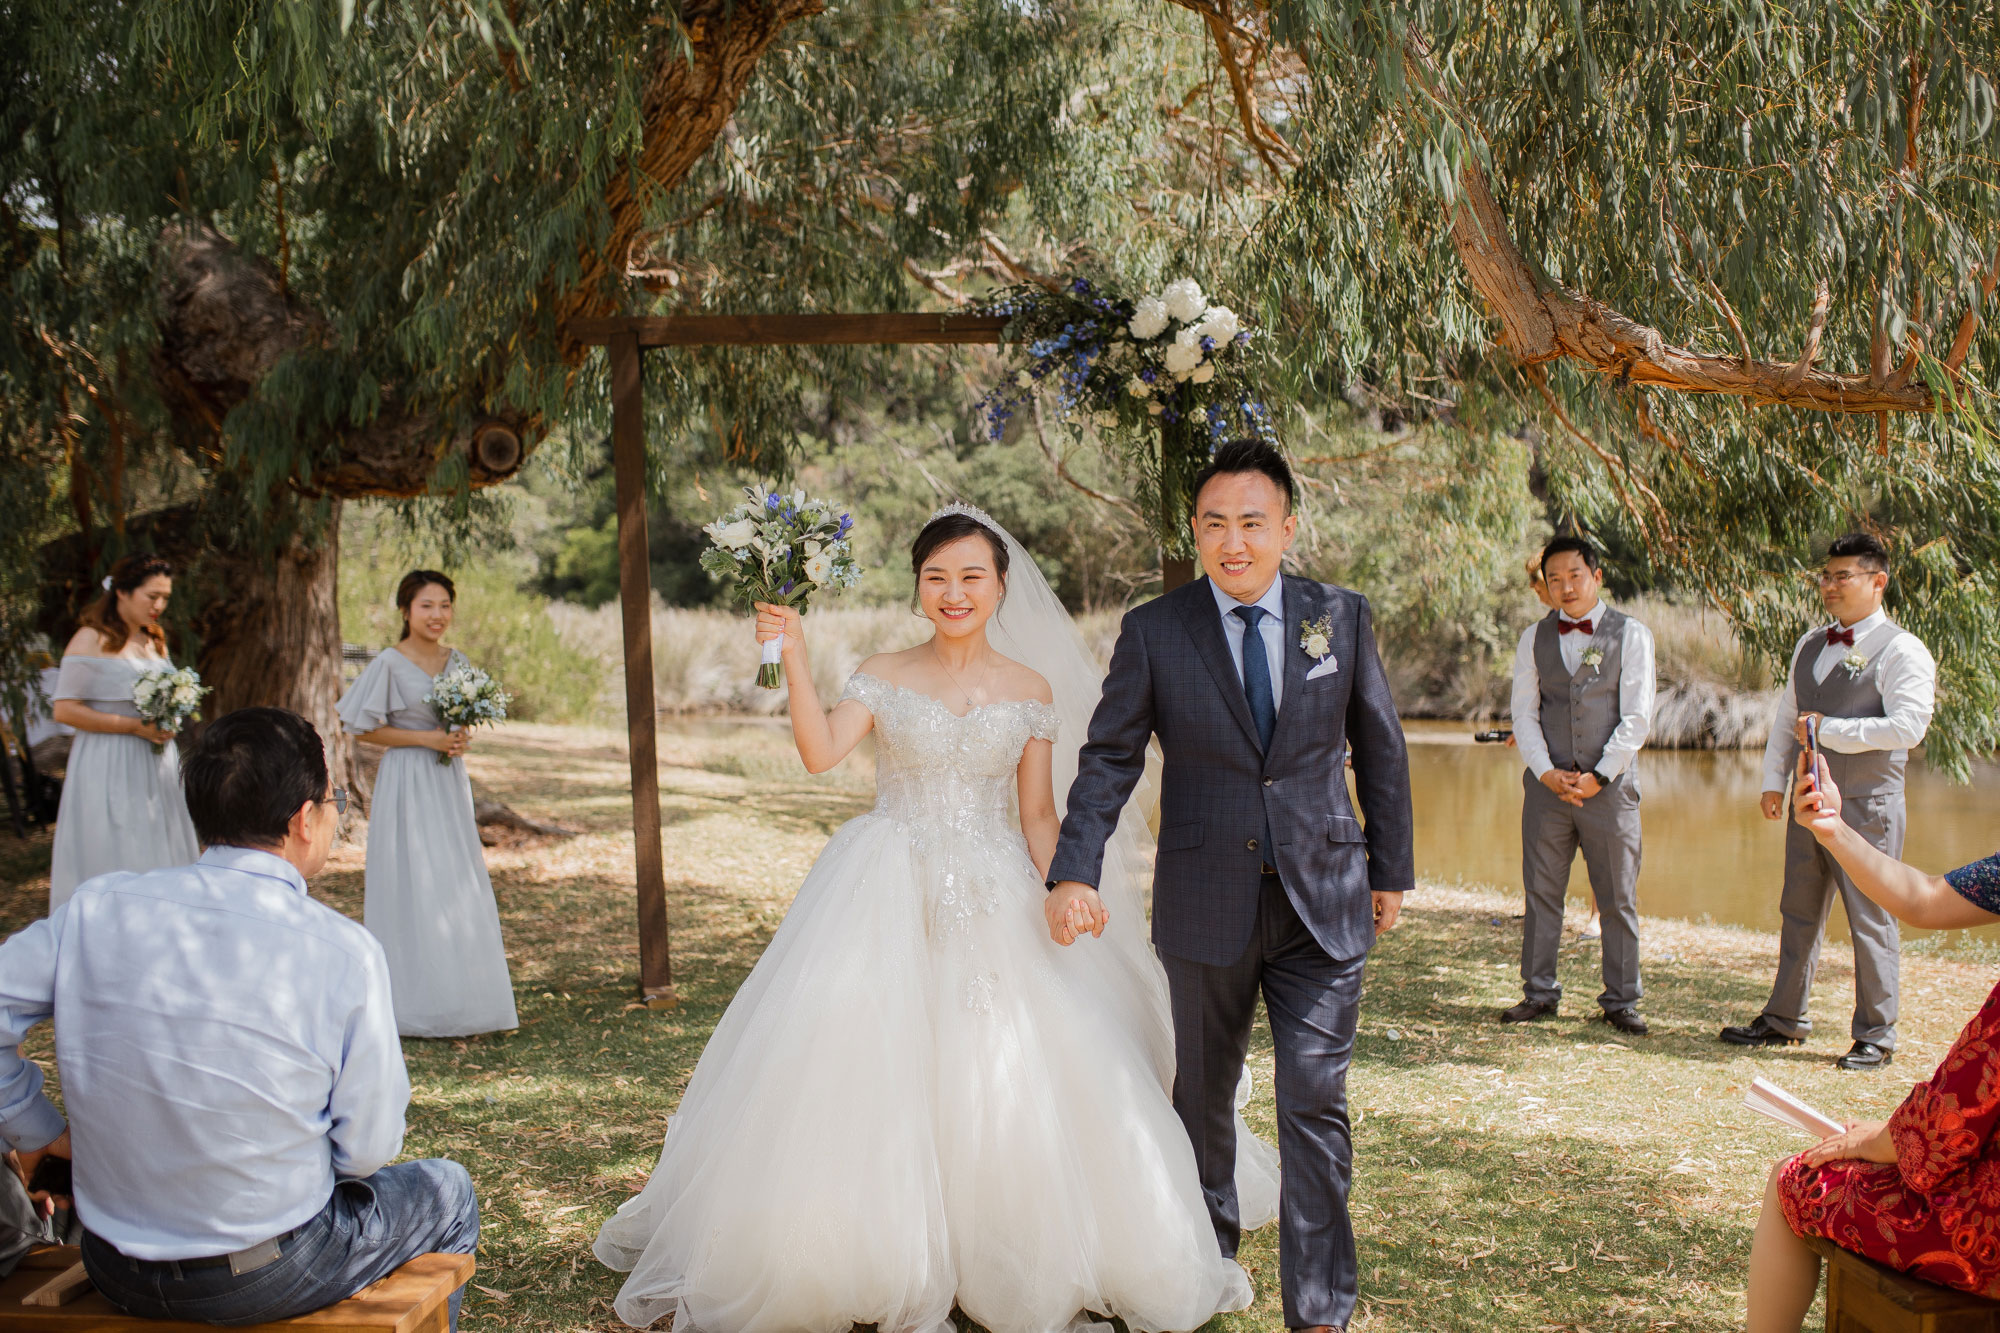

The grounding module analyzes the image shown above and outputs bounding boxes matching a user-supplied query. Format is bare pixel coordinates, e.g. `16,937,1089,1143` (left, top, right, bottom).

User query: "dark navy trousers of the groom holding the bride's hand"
1160,875,1366,1329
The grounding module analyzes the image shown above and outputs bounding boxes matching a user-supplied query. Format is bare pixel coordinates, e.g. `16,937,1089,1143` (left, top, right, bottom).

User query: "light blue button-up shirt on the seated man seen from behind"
0,847,410,1259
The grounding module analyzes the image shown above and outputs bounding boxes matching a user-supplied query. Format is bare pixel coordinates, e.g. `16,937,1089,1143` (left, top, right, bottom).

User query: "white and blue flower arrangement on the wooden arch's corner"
980,278,1276,556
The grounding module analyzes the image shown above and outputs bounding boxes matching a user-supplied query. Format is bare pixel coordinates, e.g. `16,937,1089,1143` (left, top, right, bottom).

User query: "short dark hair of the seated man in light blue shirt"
180,709,326,847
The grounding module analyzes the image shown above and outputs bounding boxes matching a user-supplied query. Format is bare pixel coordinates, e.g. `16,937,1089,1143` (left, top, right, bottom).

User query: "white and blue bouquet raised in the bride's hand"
702,486,862,691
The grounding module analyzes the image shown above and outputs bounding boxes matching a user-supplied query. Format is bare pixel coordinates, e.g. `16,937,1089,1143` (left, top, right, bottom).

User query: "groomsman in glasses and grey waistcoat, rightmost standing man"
1722,532,1938,1069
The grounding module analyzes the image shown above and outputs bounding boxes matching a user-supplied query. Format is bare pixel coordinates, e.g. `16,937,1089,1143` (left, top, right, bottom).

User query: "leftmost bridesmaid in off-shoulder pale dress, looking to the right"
48,554,202,913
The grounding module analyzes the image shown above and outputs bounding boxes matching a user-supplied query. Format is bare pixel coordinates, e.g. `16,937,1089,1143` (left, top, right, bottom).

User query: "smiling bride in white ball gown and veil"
594,504,1276,1333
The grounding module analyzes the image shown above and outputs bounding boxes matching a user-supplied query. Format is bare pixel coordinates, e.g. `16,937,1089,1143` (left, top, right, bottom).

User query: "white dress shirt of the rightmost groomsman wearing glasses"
1764,610,1938,791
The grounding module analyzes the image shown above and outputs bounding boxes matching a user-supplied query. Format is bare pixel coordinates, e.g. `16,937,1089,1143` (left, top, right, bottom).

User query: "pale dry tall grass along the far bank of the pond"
540,598,1772,749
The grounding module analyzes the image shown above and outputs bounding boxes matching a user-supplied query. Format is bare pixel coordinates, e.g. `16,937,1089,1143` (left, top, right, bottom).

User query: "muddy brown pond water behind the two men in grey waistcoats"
1406,723,2000,939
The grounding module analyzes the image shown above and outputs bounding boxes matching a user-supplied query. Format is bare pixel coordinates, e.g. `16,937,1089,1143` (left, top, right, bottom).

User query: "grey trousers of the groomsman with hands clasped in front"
1520,771,1644,1011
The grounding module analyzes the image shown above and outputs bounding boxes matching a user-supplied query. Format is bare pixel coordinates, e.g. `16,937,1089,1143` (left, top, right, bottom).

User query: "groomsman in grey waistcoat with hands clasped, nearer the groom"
1500,536,1654,1037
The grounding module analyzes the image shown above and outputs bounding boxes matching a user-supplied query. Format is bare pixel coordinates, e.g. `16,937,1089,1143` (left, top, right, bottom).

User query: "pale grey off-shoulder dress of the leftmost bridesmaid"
48,652,202,913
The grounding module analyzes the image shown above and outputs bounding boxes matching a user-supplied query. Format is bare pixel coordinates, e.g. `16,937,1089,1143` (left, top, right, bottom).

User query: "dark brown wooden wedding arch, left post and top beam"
568,314,1006,996
